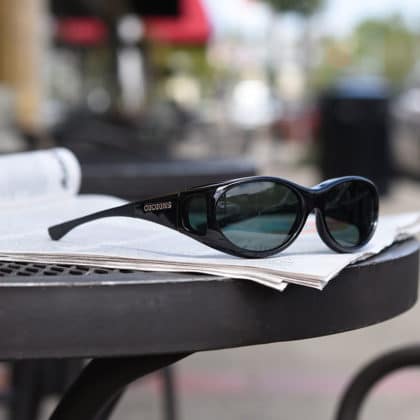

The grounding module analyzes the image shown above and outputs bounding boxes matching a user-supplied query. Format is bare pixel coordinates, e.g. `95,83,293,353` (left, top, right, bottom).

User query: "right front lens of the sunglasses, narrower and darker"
324,181,377,247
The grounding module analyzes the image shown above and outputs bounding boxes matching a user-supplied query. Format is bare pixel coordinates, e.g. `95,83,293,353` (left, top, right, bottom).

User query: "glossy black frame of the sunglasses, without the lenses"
48,176,379,258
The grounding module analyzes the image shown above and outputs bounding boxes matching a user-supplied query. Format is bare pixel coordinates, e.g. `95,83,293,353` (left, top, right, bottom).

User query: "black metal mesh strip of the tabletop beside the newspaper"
0,261,134,277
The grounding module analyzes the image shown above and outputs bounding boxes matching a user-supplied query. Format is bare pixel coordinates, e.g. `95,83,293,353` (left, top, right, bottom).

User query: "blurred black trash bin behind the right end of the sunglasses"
319,77,392,194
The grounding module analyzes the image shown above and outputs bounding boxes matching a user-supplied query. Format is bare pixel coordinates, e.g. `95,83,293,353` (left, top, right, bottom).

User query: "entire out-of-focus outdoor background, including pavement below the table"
0,0,420,420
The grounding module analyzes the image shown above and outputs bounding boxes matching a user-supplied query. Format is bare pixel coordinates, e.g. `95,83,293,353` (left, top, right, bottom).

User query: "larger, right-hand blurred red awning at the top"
144,0,211,45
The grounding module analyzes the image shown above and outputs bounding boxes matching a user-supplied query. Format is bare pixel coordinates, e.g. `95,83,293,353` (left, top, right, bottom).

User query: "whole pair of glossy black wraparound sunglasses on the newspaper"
48,176,378,258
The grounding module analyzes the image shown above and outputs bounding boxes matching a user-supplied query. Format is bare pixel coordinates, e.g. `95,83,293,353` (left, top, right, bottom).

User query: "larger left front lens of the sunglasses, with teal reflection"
216,181,300,251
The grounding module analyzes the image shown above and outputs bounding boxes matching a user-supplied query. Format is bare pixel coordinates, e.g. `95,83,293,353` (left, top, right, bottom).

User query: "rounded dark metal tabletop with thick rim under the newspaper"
0,240,418,360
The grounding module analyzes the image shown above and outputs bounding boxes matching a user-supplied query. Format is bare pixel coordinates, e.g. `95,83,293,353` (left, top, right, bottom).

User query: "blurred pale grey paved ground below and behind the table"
8,136,420,420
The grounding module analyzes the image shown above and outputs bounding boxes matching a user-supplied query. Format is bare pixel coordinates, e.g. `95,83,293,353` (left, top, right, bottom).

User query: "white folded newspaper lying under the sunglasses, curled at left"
0,149,420,290
